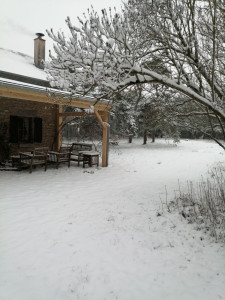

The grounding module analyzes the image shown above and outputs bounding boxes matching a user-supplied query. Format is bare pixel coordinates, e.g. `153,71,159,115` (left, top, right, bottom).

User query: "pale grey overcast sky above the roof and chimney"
0,0,122,59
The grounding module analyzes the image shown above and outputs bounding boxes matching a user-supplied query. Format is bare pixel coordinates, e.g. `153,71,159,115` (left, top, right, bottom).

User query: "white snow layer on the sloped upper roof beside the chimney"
0,48,46,80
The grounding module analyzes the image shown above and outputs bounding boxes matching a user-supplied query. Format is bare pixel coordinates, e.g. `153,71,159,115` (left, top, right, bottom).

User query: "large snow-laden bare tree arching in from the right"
46,0,225,148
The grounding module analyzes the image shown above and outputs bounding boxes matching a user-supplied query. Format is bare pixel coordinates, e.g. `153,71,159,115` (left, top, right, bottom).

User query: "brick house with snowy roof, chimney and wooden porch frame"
0,34,111,166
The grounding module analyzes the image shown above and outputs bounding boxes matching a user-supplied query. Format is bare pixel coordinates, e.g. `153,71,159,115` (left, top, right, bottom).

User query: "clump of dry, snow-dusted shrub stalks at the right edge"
173,166,225,242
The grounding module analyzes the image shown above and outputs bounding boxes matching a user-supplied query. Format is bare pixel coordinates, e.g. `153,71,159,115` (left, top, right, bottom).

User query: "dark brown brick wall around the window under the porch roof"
0,97,57,161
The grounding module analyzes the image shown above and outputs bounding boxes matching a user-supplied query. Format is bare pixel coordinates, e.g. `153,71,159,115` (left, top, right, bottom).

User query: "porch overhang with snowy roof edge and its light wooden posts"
0,74,111,167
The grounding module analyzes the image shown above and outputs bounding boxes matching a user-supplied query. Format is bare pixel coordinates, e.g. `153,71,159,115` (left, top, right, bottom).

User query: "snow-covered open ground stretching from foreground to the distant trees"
0,140,225,300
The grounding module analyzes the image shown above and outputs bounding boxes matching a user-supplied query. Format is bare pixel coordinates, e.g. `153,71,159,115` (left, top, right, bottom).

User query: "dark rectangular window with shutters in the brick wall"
10,116,42,143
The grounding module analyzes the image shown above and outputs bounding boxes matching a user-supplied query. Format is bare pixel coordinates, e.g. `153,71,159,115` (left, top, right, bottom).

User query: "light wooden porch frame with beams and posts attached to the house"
0,72,111,167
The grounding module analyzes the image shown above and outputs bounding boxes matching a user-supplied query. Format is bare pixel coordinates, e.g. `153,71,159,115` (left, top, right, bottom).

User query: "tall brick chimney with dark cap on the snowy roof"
34,33,45,69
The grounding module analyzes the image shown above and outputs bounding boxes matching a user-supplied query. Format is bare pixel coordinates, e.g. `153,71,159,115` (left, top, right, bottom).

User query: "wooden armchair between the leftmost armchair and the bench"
48,146,71,169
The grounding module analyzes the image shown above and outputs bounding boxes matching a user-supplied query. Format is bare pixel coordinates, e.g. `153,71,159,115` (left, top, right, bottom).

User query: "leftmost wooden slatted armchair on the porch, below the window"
19,152,47,173
